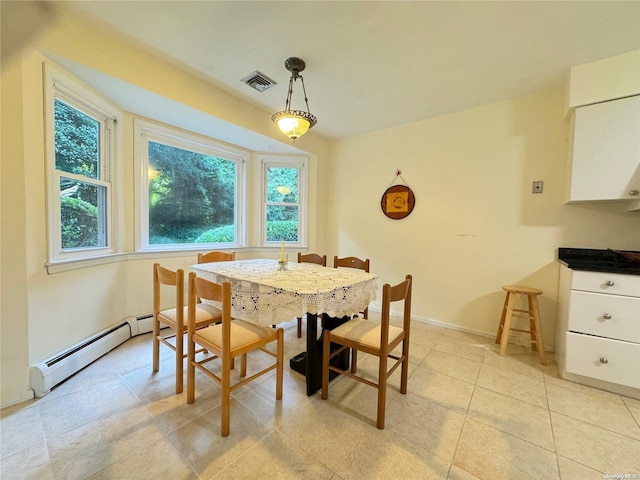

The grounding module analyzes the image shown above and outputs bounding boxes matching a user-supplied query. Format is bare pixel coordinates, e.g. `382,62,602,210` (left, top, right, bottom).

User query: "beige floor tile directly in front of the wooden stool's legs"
476,365,547,408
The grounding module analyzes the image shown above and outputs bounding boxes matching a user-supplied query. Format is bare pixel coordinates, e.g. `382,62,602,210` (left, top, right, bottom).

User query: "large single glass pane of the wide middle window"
148,141,237,245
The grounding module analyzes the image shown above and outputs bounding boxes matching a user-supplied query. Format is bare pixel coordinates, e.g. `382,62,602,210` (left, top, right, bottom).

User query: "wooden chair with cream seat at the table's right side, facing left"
322,275,412,430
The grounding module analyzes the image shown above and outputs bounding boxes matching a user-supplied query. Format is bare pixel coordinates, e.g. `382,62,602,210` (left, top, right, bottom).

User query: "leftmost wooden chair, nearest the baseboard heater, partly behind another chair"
153,263,222,393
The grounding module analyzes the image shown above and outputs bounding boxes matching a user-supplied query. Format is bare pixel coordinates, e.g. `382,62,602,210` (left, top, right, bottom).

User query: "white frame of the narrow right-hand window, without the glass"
258,154,309,248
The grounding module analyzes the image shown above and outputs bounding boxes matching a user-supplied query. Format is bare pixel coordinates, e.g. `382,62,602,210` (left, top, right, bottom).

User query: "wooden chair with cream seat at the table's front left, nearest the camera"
187,272,284,437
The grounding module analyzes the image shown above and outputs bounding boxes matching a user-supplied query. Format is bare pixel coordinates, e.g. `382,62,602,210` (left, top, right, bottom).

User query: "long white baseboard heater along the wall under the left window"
29,315,153,397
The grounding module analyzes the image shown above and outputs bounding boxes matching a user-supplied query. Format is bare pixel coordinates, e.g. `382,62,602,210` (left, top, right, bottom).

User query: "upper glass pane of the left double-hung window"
54,99,100,178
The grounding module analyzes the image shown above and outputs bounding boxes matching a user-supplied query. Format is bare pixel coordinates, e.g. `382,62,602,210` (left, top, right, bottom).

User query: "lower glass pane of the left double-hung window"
60,177,107,250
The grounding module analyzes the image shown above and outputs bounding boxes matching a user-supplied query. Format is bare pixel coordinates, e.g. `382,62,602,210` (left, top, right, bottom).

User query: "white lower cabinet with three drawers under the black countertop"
556,265,640,398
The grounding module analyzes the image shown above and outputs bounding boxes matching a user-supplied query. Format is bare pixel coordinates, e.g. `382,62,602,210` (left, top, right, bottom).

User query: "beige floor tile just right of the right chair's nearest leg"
385,393,464,462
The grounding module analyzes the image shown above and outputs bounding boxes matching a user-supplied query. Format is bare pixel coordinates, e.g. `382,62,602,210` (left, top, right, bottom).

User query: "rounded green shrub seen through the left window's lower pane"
60,197,98,249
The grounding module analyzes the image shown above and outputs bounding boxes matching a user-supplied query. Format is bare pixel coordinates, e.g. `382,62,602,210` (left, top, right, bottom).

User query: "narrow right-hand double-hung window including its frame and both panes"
261,156,307,246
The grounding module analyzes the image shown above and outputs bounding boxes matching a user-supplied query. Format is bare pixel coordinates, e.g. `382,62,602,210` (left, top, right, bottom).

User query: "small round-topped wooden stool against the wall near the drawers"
496,285,547,365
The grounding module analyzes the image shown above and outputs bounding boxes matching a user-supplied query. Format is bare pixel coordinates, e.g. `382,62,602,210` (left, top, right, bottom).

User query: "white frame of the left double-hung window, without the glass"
43,63,123,265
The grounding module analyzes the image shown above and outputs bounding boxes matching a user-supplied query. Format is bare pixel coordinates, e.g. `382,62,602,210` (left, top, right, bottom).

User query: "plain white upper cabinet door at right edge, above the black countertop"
569,96,640,201
